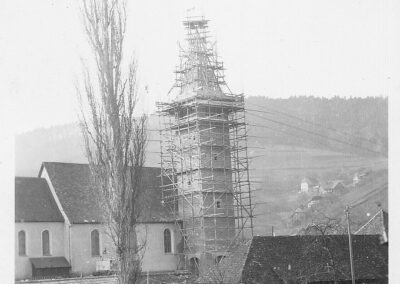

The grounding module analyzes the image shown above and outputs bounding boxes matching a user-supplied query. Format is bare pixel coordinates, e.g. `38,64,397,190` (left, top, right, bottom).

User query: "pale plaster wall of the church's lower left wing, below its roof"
15,222,68,279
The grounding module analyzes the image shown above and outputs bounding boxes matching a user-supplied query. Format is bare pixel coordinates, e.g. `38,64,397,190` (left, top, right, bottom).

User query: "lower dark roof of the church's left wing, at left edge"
15,177,64,222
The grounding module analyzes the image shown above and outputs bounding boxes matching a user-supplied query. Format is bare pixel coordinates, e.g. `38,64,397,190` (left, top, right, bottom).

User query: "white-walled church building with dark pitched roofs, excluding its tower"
15,162,182,279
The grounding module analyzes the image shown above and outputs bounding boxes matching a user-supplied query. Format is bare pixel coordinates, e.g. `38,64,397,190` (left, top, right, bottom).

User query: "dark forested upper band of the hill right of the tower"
246,97,388,155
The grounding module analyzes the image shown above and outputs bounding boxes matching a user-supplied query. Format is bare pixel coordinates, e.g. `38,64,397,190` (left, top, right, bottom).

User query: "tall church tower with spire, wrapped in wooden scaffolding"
157,17,253,273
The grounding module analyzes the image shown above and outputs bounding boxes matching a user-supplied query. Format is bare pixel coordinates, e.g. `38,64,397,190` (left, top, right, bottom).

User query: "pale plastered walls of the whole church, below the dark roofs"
15,222,181,279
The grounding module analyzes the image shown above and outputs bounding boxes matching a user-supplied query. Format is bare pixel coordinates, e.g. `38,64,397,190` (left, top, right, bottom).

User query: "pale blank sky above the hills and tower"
0,0,400,133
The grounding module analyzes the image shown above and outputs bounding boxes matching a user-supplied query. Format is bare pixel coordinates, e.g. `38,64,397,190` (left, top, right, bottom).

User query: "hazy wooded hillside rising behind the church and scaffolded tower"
15,97,388,235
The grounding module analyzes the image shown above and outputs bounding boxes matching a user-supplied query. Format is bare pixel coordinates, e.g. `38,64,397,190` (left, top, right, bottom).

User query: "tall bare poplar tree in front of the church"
78,0,146,284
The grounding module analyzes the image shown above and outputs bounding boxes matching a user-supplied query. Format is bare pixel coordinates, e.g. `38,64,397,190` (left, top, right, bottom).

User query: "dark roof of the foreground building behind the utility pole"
242,235,388,283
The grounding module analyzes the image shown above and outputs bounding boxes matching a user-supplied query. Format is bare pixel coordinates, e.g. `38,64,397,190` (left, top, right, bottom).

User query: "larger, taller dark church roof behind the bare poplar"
39,162,173,224
